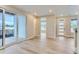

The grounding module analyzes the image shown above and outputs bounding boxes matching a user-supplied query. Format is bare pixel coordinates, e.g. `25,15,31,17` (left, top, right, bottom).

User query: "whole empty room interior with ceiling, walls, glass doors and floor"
0,5,79,54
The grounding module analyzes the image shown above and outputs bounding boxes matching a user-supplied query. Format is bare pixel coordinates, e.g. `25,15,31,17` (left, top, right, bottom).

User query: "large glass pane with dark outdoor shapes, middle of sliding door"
5,12,16,44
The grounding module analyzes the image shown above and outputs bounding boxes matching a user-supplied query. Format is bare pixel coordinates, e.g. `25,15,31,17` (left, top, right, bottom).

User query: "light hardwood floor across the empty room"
0,33,74,54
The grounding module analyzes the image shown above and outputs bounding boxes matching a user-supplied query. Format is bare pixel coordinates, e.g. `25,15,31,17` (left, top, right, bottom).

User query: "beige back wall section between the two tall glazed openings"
46,16,56,39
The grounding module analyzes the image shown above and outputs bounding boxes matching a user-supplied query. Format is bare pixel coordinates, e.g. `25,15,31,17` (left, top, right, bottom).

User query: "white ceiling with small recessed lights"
13,5,79,16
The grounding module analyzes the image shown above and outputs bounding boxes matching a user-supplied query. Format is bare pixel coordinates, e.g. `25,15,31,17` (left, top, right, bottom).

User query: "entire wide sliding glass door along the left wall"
0,9,26,48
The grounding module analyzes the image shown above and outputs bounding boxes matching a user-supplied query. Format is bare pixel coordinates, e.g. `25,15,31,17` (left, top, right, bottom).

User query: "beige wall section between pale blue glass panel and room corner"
27,14,36,38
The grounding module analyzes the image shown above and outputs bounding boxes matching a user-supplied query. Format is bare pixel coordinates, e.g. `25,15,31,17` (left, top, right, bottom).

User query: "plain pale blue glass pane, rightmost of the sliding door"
18,16,26,40
